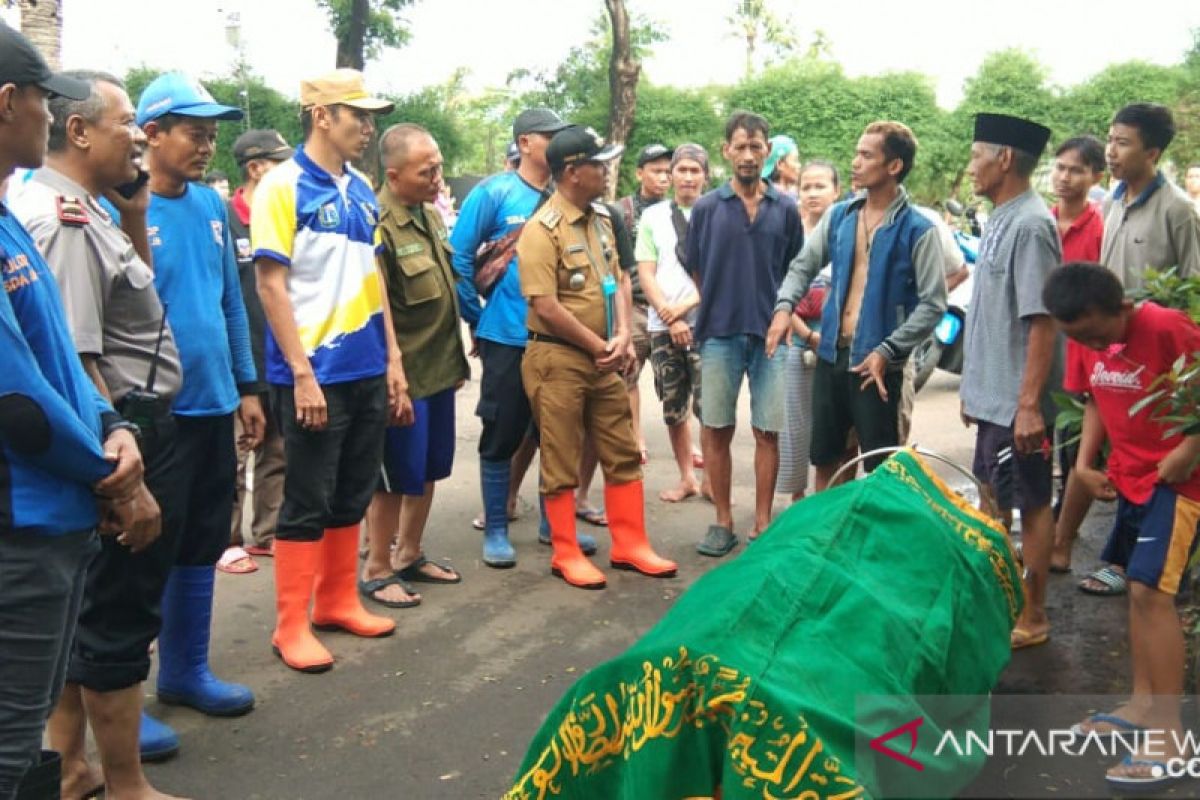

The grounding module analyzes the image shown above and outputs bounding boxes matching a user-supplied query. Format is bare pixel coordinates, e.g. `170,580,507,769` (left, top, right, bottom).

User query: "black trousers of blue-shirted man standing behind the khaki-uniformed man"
475,339,533,461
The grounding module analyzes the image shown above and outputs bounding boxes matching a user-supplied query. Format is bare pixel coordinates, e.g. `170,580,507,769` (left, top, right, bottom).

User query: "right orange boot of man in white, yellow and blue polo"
312,525,396,637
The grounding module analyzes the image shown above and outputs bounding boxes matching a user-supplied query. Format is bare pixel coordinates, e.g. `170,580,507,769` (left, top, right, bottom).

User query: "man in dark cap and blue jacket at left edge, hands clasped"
0,24,160,800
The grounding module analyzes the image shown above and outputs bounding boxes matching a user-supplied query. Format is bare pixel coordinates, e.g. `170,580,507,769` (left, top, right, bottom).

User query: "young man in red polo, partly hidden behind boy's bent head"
1050,136,1104,572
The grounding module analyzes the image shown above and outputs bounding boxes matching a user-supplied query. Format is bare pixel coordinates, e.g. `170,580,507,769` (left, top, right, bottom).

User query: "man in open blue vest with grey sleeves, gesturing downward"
767,122,946,492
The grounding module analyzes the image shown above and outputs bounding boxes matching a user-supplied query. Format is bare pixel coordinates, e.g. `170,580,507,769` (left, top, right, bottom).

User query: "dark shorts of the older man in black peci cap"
973,420,1054,511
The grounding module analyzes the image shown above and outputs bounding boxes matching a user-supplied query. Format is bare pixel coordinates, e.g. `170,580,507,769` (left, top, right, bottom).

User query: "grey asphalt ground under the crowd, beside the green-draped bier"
136,369,1156,800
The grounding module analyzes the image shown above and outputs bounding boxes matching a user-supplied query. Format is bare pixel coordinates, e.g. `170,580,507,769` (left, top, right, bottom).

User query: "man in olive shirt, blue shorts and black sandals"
359,124,469,608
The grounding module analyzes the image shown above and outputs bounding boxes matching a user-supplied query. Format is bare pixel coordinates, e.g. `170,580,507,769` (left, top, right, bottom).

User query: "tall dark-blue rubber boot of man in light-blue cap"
158,566,254,717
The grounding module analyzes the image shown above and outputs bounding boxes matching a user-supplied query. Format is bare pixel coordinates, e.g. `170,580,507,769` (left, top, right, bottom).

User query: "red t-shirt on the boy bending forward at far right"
1063,302,1200,504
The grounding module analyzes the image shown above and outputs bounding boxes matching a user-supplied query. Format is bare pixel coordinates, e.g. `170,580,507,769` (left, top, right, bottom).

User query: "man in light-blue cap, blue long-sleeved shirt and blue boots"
137,72,265,729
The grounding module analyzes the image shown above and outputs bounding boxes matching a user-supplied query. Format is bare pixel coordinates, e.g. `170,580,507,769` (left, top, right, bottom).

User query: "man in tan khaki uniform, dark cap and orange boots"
517,125,677,589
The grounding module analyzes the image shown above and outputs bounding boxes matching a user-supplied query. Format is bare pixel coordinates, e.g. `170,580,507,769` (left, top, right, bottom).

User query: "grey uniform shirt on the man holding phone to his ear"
12,167,182,408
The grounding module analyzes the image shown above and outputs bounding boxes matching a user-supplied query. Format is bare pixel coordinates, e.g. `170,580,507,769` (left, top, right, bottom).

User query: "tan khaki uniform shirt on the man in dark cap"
517,192,620,338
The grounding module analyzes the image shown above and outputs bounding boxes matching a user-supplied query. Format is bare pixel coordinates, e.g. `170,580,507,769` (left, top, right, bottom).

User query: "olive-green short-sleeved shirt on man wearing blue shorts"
378,187,470,399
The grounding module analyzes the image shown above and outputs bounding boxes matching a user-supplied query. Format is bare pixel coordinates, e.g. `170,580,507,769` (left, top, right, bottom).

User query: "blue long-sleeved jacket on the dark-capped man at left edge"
0,204,113,535
